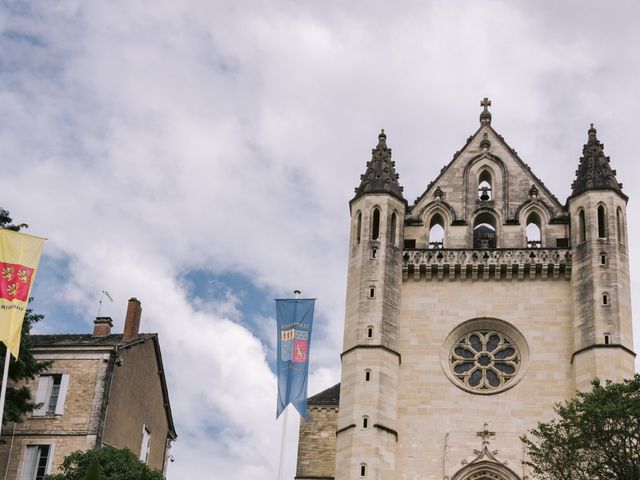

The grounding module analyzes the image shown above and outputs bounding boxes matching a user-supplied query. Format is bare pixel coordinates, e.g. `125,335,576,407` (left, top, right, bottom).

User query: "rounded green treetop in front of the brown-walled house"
45,446,164,480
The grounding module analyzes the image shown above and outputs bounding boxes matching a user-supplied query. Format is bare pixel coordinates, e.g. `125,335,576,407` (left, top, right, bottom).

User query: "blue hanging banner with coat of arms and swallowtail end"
276,298,315,419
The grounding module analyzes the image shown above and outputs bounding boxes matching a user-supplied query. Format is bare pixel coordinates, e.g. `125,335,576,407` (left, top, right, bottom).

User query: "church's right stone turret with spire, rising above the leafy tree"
568,124,634,391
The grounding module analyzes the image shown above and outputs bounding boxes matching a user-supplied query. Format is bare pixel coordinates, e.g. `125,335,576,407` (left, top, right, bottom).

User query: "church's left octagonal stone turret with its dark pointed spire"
336,130,407,479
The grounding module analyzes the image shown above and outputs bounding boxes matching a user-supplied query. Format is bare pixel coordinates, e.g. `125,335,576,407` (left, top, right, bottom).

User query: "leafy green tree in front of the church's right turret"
522,374,640,480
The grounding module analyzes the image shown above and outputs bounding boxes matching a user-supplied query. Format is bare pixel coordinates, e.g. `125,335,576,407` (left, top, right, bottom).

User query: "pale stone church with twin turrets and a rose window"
296,99,635,480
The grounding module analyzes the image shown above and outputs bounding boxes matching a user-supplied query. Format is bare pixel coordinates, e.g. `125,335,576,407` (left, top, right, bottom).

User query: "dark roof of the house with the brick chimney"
31,333,178,440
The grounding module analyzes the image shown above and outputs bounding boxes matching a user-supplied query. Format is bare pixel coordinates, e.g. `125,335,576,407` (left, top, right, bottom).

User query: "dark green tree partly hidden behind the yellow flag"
0,208,51,425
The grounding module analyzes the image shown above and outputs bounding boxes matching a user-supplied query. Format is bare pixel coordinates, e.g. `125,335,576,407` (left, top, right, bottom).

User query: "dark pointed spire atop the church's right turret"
571,123,626,198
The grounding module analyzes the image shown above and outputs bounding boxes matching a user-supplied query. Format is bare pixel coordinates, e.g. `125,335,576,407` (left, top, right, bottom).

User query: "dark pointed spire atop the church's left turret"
352,130,405,201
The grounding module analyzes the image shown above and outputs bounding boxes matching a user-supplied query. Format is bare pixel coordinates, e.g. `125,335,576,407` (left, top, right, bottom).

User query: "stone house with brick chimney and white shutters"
0,298,177,480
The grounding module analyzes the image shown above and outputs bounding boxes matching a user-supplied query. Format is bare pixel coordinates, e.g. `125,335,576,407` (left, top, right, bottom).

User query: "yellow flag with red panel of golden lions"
0,228,44,358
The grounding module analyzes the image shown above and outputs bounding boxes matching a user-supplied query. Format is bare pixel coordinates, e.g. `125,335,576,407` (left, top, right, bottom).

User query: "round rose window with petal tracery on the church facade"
449,331,521,391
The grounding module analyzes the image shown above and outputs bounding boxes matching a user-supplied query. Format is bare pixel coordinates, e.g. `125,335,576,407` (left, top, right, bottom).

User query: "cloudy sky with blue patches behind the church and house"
0,0,640,480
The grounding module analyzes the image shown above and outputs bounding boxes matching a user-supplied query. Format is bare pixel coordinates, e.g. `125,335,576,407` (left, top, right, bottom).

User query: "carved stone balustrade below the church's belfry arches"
402,248,571,281
